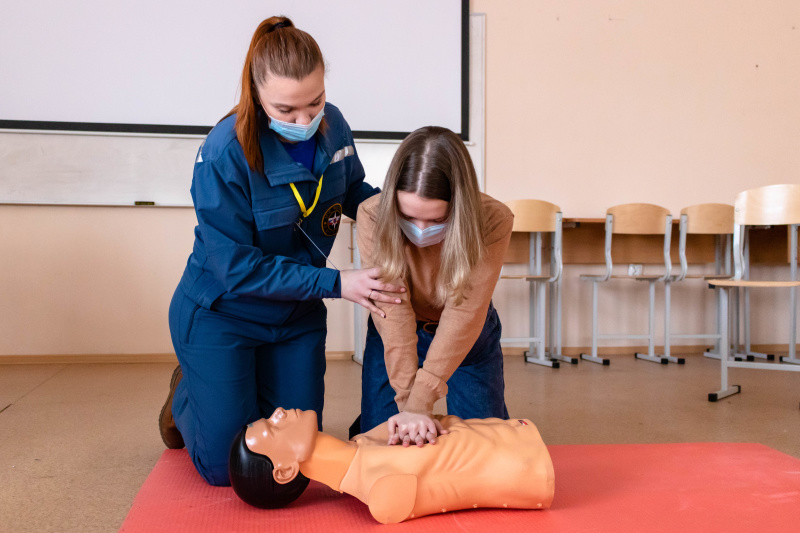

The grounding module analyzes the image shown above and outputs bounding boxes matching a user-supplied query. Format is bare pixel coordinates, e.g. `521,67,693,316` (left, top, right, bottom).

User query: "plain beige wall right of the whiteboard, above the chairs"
472,0,800,217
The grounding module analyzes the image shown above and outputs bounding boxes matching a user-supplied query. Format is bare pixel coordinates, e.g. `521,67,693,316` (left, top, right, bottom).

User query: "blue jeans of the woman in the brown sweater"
361,304,508,432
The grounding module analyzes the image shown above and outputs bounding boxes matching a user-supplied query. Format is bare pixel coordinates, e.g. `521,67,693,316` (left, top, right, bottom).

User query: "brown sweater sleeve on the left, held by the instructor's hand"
356,197,419,410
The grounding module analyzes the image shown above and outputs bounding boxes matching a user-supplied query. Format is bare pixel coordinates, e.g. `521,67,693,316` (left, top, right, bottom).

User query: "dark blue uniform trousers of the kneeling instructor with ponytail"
169,289,327,485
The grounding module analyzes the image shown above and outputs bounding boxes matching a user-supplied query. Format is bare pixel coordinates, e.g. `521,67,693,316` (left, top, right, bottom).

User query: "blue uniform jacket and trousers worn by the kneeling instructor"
169,104,379,485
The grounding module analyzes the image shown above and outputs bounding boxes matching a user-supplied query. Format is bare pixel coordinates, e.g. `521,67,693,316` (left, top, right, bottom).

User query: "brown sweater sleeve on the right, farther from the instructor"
402,213,514,416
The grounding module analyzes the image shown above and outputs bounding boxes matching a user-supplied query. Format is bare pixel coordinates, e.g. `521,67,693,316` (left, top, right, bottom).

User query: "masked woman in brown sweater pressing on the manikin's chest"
358,127,514,446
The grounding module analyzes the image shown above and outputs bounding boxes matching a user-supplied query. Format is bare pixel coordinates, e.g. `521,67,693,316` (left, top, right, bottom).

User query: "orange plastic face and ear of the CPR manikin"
245,407,317,483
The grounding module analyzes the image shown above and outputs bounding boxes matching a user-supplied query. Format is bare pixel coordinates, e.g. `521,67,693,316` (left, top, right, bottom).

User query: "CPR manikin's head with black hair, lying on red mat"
228,407,317,509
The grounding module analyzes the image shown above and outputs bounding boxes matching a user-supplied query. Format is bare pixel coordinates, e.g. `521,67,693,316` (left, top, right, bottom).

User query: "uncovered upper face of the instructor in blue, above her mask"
256,66,325,126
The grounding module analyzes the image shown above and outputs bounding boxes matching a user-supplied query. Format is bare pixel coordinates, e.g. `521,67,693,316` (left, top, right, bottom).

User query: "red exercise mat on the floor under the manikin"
120,443,800,533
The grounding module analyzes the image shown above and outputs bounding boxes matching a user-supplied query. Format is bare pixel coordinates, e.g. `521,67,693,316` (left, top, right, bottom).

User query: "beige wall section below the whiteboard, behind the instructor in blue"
0,205,352,355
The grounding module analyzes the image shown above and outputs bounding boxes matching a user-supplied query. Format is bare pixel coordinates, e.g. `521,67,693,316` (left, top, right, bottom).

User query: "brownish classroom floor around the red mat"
0,356,800,533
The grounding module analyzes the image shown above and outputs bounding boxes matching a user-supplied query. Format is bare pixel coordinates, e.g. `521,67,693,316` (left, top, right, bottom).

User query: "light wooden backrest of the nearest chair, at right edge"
734,184,800,226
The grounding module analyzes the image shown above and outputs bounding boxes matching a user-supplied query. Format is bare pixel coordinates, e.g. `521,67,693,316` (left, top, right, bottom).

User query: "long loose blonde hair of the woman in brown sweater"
374,126,486,306
